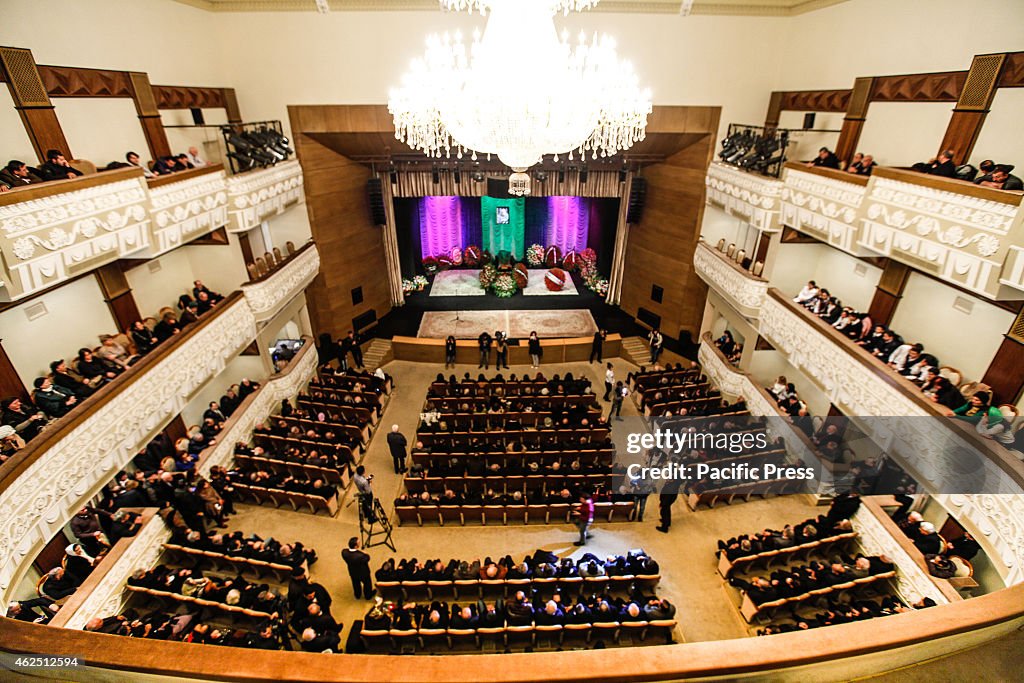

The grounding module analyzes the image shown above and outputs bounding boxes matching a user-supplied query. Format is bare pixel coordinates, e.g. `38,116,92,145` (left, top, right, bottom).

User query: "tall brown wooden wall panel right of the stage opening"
620,135,714,348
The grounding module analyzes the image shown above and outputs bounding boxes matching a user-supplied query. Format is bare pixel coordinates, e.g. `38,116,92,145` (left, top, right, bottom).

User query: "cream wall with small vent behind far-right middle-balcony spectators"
892,273,1014,387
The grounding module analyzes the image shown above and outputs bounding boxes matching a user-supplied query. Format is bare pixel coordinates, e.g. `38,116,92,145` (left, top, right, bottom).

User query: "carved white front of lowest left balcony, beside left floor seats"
200,339,316,474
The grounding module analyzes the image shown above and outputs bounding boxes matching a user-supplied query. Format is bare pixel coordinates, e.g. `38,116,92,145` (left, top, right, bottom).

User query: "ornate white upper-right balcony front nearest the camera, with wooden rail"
859,168,1024,299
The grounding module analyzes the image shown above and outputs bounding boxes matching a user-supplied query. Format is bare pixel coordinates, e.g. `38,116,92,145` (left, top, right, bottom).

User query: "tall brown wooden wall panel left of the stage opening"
289,108,391,337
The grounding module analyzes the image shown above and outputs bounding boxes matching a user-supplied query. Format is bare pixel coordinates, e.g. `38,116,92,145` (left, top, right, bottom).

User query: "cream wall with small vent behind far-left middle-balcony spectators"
0,275,117,390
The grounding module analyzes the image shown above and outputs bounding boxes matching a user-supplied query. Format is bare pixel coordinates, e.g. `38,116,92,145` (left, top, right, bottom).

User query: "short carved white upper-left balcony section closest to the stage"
227,160,304,232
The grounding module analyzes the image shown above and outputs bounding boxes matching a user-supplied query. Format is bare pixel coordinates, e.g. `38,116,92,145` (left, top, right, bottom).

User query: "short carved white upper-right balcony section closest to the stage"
705,162,782,232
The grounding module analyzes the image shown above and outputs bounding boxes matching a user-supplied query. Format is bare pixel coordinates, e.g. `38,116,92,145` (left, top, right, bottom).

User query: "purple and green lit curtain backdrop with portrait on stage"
394,196,618,278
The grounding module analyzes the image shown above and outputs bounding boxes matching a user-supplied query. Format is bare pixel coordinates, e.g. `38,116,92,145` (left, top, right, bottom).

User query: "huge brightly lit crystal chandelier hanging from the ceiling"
388,0,651,195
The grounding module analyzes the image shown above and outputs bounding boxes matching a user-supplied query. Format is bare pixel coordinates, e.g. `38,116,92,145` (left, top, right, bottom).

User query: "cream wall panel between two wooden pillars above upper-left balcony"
53,97,153,168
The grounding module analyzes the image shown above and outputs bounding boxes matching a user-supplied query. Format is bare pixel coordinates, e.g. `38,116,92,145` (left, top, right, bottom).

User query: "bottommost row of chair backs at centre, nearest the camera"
359,620,676,653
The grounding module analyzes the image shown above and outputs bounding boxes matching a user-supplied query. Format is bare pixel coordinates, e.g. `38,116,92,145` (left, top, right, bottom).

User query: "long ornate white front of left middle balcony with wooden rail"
0,292,256,595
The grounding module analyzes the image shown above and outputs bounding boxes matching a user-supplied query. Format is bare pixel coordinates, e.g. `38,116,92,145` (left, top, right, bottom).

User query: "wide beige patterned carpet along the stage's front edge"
417,308,597,339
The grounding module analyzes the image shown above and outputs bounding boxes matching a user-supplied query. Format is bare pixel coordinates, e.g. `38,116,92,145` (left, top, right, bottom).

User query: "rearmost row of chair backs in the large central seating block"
395,501,636,526
